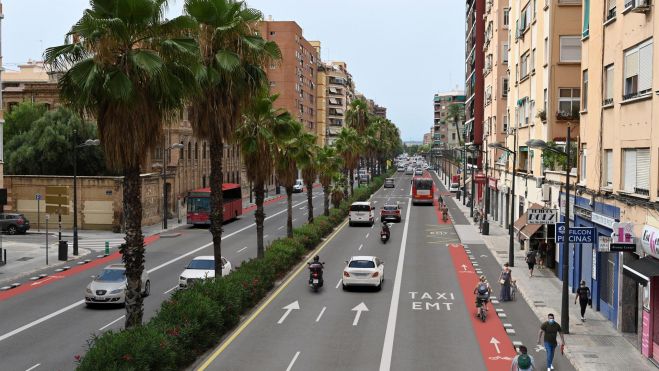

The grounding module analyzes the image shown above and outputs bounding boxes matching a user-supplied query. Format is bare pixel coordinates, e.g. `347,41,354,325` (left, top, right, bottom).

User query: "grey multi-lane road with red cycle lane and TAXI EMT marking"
0,174,572,371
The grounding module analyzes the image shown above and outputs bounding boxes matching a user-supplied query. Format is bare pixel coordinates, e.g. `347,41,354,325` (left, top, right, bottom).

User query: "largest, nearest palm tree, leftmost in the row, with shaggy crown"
44,0,196,328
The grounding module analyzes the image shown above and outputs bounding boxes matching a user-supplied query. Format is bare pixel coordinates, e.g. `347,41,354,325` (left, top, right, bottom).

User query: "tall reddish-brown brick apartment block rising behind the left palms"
260,20,320,134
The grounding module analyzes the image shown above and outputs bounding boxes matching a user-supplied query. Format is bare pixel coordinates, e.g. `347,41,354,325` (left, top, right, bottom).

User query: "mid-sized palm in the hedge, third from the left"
235,89,290,258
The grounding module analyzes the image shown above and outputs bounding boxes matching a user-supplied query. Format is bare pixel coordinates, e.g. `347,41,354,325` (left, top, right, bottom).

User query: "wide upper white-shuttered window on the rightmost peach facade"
623,40,652,100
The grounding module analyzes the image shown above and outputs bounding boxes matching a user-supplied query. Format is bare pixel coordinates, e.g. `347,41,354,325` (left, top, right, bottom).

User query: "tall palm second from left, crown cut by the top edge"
184,0,281,277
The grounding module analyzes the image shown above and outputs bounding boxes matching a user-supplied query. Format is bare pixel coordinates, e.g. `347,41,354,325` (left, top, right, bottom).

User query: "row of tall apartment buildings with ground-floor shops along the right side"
440,0,659,360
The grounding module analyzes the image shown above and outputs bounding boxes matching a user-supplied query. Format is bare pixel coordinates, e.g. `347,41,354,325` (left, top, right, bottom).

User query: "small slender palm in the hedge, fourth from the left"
275,118,303,237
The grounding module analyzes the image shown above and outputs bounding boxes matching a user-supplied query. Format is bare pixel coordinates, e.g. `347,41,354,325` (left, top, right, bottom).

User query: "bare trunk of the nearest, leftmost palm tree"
120,166,144,328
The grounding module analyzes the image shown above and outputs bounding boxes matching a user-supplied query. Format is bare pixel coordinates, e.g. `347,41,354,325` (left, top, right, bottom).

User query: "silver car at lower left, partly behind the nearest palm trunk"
85,264,151,307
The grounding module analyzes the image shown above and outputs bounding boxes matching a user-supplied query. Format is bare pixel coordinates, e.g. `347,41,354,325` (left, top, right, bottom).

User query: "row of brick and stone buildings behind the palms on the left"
0,19,386,229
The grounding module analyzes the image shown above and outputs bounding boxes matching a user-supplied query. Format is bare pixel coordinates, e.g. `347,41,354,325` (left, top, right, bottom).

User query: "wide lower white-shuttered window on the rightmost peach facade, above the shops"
622,148,650,196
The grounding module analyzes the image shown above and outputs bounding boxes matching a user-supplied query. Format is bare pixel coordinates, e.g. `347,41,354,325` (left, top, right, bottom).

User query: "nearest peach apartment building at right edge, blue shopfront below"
584,0,659,363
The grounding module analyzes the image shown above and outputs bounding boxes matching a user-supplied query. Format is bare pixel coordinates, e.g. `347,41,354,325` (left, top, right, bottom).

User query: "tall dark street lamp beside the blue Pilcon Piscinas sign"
526,127,570,334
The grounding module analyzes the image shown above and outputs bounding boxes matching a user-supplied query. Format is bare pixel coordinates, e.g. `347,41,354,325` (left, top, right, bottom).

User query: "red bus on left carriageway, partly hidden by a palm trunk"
186,183,243,226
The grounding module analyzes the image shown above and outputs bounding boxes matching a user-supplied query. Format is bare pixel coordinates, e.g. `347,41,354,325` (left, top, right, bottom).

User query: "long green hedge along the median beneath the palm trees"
78,173,384,371
